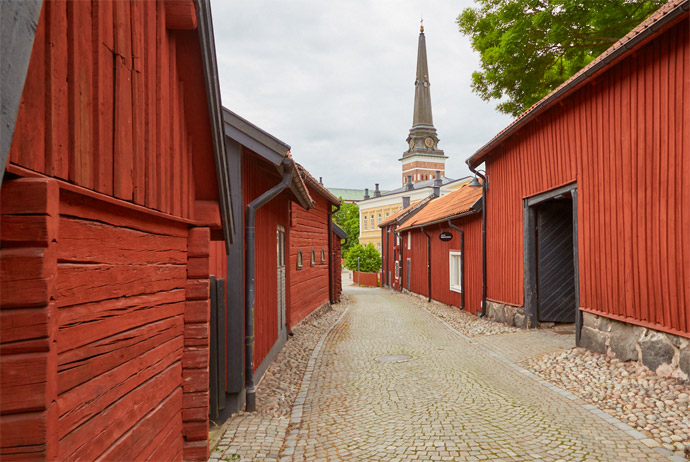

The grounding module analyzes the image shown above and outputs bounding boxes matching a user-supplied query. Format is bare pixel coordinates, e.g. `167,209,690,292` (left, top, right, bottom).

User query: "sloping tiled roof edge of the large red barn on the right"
467,0,690,167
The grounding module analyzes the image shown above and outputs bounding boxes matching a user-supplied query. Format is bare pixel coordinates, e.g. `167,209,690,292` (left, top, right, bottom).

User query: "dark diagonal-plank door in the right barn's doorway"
536,199,576,322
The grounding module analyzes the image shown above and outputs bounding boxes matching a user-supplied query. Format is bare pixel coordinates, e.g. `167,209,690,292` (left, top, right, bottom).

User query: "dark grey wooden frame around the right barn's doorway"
522,182,582,346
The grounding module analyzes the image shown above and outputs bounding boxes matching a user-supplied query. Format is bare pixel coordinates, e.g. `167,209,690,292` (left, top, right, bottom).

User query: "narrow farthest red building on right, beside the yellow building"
379,194,436,290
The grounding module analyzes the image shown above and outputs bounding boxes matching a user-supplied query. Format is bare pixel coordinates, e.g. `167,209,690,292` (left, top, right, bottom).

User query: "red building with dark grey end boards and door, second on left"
217,109,314,416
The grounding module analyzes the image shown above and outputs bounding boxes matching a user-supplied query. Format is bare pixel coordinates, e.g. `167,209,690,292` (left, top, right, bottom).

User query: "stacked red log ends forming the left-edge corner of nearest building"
0,178,59,460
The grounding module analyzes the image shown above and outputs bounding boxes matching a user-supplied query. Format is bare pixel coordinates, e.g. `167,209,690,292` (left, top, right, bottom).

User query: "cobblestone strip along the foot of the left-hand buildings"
256,296,349,417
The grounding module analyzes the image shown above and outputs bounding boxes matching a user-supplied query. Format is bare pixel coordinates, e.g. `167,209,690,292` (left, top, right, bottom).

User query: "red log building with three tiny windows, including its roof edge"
287,164,340,329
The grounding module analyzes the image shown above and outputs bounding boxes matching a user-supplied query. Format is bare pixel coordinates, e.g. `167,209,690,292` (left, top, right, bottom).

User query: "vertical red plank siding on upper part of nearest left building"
10,0,217,218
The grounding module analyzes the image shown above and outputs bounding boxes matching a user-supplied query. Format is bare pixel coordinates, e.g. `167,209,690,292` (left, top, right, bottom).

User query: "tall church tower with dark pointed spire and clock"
399,25,447,186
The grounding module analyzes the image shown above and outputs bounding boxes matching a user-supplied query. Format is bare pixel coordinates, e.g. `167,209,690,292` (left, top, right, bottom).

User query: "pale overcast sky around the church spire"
211,0,512,189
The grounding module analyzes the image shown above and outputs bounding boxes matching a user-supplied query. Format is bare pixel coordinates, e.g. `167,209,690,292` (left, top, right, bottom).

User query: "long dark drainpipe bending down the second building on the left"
244,158,294,412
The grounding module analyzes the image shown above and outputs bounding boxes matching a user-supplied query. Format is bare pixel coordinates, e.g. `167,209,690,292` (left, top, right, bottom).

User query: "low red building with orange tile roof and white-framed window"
397,185,482,314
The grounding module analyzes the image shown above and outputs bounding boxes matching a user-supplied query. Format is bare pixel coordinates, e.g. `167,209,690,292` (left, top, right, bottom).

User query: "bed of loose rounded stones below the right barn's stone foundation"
522,348,690,458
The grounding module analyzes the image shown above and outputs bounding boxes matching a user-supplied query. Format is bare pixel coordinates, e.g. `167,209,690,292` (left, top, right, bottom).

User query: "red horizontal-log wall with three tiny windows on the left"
288,187,330,326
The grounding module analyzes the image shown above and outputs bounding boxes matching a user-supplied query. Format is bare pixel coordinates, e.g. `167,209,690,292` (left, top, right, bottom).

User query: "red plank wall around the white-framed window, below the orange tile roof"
403,214,482,314
